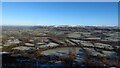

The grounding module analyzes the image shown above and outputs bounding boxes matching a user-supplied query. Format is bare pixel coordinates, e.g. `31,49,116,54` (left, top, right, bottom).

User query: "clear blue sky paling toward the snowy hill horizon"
2,2,118,26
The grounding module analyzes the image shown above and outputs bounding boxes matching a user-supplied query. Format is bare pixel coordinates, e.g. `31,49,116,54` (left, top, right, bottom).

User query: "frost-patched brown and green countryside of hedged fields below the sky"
0,25,120,68
